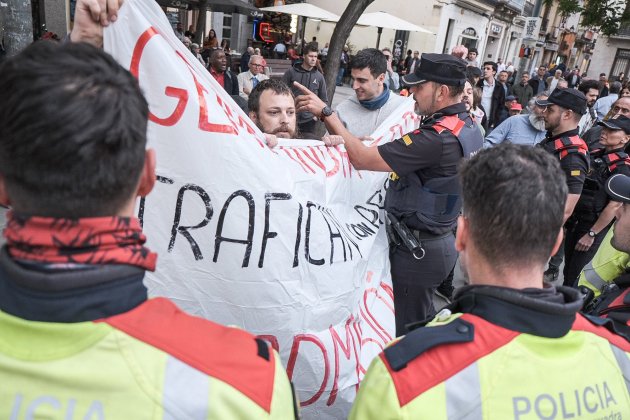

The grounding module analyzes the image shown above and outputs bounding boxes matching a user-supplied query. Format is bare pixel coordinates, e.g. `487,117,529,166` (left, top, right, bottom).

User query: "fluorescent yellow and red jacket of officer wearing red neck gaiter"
0,298,294,420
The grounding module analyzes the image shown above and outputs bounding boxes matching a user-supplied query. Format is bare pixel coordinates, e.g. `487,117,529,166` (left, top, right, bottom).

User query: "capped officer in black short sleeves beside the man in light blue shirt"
536,89,589,281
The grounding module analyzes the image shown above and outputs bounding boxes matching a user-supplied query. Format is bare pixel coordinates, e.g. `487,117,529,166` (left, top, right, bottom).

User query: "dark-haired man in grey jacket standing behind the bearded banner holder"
282,44,328,139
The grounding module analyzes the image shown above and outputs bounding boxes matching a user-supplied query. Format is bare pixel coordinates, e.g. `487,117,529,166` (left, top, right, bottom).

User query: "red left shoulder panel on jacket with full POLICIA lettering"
380,314,520,407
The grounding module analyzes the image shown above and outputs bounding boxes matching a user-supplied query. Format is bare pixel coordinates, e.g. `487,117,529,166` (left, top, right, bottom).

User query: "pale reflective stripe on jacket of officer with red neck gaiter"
162,356,210,420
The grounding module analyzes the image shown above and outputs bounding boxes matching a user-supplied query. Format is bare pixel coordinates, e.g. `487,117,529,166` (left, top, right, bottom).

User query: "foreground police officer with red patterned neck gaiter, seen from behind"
0,39,296,420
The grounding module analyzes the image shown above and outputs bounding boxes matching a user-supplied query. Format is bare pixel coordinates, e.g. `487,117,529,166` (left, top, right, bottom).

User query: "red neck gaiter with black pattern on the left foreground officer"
4,211,157,271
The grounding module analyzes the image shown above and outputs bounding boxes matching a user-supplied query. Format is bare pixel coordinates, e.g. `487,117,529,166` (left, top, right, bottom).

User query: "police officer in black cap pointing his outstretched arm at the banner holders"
296,54,483,336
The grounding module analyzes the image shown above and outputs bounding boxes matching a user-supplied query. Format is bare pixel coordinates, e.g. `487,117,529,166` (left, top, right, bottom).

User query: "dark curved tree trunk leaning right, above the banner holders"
324,0,374,103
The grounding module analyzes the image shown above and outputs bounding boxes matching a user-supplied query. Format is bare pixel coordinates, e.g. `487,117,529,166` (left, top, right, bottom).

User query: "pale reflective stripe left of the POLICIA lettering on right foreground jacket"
444,362,483,420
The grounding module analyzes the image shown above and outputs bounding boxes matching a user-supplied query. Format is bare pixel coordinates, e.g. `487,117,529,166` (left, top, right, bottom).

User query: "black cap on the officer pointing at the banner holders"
403,53,466,86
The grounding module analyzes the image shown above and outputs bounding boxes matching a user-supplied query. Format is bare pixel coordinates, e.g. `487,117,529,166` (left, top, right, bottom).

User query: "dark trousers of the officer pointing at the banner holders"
390,234,457,337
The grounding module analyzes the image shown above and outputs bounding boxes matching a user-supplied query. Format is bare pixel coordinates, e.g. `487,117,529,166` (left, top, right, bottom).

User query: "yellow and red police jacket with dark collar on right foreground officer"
350,286,630,420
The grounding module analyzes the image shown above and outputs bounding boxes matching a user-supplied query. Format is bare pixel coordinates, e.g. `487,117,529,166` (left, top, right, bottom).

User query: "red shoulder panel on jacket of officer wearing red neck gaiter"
99,298,275,412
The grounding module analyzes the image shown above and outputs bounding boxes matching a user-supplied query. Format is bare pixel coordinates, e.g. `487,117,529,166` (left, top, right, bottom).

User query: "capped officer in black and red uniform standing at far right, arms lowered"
564,116,630,286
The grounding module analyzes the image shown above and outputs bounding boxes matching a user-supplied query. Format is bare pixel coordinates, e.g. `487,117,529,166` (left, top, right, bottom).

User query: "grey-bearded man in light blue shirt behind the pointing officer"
483,92,549,147
